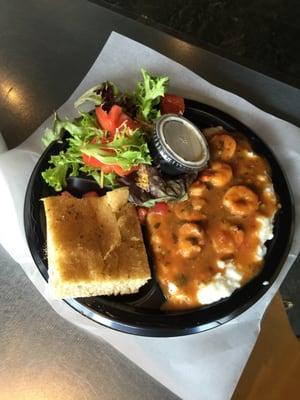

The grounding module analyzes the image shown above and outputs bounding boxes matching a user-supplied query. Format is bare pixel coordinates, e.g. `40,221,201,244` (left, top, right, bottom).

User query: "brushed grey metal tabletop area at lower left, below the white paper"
0,246,177,400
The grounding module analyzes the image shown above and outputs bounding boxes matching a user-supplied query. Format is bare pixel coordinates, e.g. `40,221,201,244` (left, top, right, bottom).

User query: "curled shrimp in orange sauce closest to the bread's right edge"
177,222,205,258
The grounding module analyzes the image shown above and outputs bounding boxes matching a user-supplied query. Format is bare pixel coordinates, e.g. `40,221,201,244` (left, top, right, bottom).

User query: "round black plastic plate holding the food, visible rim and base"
24,100,294,336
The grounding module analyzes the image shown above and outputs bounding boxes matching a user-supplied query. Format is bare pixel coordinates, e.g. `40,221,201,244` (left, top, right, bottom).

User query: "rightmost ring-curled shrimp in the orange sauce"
223,185,259,217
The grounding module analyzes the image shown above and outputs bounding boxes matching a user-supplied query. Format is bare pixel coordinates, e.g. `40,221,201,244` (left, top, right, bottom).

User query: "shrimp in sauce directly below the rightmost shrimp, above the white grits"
210,222,245,256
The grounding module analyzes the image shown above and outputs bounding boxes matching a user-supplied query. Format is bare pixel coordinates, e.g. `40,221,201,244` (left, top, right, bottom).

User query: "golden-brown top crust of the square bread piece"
43,188,151,290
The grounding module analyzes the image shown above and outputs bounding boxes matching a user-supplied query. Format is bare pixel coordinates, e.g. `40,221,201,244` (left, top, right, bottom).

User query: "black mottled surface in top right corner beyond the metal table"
92,0,300,88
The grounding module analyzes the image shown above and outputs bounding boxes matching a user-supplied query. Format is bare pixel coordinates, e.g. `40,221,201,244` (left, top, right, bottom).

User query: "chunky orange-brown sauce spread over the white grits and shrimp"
147,132,278,309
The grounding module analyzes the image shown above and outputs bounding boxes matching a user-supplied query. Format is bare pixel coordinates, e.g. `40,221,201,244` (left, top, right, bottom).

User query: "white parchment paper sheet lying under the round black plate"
0,32,300,400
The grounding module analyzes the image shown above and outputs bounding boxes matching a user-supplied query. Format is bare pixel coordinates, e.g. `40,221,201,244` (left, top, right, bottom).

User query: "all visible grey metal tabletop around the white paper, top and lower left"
0,0,300,399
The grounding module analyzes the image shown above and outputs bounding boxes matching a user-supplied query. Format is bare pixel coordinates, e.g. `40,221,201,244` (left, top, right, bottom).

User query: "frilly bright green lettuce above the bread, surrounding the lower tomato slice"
42,113,151,191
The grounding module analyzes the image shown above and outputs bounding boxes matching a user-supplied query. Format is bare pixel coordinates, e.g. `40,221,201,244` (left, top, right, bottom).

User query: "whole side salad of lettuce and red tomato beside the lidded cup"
42,69,185,207
